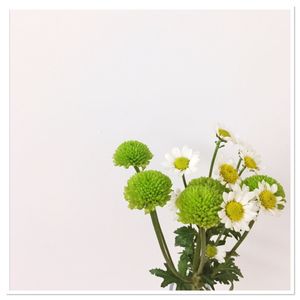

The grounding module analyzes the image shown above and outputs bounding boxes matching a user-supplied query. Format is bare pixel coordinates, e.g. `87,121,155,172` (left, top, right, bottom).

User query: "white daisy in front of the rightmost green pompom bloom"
254,180,285,215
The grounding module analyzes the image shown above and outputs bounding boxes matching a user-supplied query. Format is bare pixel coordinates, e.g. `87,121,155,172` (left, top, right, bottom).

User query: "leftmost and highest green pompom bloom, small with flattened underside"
113,141,153,169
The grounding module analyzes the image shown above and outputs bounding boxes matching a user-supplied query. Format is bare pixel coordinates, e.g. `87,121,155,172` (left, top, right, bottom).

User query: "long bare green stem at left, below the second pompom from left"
150,210,189,282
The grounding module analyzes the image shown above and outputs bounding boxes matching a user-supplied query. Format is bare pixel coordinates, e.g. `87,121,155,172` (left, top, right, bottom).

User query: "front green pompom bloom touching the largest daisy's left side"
176,184,223,228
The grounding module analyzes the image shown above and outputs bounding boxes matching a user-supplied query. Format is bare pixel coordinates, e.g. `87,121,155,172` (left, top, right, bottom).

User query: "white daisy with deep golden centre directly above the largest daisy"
214,155,241,186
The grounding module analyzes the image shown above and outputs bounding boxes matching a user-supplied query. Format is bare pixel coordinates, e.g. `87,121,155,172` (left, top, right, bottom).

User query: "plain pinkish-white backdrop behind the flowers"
10,11,290,290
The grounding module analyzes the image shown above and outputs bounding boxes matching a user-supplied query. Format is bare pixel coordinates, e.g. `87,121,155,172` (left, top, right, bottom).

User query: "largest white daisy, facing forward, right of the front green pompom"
218,184,258,232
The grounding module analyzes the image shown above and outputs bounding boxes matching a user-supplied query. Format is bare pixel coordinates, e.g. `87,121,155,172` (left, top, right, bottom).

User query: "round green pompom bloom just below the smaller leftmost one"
124,170,172,212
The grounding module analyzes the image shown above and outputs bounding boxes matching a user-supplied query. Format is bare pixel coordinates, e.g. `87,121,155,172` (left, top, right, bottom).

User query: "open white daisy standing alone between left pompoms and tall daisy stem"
164,146,200,175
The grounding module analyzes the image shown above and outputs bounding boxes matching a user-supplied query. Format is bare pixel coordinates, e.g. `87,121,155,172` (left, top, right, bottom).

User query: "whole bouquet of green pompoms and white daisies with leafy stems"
113,127,286,290
